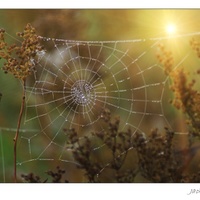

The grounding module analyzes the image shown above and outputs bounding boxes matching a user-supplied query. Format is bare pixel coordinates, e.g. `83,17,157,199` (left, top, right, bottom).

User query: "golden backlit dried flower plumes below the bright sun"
157,42,200,134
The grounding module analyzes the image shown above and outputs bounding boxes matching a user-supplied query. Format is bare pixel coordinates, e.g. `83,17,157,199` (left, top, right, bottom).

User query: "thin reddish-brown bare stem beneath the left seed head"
13,80,25,183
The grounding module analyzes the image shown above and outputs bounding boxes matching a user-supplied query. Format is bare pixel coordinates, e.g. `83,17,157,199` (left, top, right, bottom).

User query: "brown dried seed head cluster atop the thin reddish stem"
0,24,43,80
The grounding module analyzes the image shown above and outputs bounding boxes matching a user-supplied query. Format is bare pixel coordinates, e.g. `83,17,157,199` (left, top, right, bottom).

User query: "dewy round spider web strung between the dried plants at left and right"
1,30,199,181
